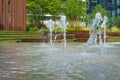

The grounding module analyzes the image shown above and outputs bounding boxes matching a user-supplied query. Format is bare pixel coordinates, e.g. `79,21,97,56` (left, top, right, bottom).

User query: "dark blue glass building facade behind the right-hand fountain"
87,0,120,16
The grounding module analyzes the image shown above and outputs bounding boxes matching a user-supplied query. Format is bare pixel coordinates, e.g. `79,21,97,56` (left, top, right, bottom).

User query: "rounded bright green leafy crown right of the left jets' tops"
63,0,86,21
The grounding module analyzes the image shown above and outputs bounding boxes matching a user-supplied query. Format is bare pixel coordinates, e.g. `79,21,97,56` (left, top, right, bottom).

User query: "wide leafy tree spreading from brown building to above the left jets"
27,0,62,28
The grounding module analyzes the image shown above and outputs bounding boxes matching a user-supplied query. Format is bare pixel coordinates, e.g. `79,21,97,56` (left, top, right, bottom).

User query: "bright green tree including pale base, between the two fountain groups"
61,0,86,27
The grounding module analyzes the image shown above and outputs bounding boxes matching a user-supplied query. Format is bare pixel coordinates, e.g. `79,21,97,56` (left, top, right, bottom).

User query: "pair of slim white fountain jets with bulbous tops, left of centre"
43,14,67,49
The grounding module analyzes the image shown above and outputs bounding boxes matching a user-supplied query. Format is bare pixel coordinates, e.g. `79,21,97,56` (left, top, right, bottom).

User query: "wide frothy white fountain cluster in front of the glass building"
87,12,107,45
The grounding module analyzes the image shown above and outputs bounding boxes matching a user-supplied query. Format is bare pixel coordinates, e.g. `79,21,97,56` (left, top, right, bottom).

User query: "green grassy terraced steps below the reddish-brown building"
0,30,42,43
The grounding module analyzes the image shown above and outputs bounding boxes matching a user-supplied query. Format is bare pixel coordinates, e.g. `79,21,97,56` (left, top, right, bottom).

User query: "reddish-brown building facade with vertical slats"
0,0,26,31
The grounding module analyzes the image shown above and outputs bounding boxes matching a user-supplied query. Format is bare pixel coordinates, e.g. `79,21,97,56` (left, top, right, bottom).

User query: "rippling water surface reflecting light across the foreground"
0,43,120,80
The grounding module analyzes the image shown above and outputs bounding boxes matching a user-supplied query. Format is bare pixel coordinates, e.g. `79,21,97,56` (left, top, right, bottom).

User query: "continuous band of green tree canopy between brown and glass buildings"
27,0,86,28
